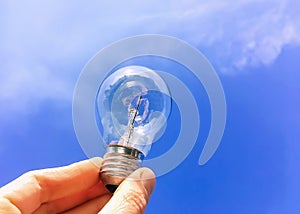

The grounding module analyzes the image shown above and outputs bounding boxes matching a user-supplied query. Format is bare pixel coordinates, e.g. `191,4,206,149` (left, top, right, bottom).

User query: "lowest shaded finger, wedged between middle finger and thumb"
64,193,111,214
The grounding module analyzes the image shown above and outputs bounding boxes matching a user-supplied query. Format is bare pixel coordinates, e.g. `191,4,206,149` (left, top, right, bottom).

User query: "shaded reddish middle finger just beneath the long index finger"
34,181,111,214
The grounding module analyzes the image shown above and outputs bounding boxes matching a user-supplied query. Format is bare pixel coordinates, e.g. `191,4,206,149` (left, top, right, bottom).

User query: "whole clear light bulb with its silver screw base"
96,66,171,192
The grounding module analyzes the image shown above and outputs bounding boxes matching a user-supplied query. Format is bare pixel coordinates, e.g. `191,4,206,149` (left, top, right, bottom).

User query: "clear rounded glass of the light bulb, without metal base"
96,66,171,156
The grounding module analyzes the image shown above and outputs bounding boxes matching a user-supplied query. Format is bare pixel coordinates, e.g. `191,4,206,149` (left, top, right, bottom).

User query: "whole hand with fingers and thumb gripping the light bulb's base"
0,158,155,214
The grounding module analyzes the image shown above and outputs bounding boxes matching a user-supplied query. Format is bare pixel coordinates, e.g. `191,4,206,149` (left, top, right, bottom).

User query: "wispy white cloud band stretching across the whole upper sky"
0,0,300,117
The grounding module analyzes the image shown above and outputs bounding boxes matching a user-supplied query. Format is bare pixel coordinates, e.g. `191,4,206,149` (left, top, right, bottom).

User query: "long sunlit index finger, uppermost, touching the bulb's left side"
0,158,102,213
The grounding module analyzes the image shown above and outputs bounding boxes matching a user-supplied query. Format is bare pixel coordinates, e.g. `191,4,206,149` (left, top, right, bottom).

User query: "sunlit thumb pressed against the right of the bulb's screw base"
99,168,155,214
